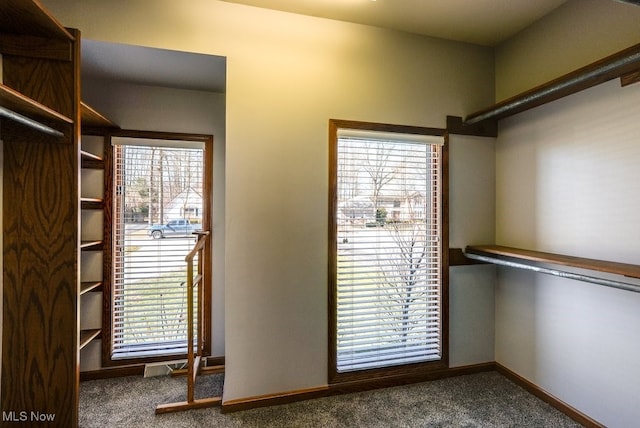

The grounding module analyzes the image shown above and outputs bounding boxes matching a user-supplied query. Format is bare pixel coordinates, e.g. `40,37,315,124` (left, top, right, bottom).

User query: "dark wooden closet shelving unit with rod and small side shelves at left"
0,0,116,427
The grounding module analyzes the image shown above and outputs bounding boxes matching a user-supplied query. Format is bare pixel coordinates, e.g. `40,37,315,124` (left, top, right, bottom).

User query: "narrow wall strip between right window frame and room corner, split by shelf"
449,135,496,367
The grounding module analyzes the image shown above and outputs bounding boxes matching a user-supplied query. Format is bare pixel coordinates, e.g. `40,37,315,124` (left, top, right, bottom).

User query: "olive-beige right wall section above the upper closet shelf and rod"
496,0,640,101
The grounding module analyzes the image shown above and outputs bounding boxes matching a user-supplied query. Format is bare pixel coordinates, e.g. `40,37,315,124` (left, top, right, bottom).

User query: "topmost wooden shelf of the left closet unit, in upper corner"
0,0,75,41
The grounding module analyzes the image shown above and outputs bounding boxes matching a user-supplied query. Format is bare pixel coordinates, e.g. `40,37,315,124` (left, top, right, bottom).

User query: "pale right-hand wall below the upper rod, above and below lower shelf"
495,81,640,427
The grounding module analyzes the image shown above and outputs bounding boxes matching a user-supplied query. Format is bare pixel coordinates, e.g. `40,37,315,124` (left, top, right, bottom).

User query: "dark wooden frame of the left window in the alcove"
102,130,213,368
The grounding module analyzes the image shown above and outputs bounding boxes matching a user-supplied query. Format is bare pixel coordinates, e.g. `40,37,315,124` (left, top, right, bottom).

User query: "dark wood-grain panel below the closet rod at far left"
1,122,78,426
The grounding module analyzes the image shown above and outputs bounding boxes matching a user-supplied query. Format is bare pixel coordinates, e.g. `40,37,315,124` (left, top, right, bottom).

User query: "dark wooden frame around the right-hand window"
328,119,449,384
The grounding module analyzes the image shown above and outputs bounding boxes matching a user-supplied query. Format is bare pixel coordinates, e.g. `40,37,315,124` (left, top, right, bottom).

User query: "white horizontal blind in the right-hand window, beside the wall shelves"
335,129,444,372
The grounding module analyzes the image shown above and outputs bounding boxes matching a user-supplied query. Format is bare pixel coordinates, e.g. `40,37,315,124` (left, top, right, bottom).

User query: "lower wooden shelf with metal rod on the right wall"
465,245,640,293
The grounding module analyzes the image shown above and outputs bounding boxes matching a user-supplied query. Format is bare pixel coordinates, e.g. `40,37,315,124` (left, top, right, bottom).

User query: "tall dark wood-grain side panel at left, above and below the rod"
0,24,80,427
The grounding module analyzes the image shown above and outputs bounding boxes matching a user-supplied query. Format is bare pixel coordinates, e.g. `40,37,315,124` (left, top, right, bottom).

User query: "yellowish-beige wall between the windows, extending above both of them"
44,0,494,400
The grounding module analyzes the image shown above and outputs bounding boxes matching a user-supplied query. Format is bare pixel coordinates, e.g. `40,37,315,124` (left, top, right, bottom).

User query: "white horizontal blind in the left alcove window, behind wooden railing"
111,145,203,359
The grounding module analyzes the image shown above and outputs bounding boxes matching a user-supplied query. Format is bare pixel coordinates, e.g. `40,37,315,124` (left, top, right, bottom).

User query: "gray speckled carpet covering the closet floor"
80,372,580,428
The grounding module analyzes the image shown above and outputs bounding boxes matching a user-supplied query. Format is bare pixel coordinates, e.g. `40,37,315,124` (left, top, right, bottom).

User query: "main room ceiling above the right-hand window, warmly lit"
223,0,566,46
